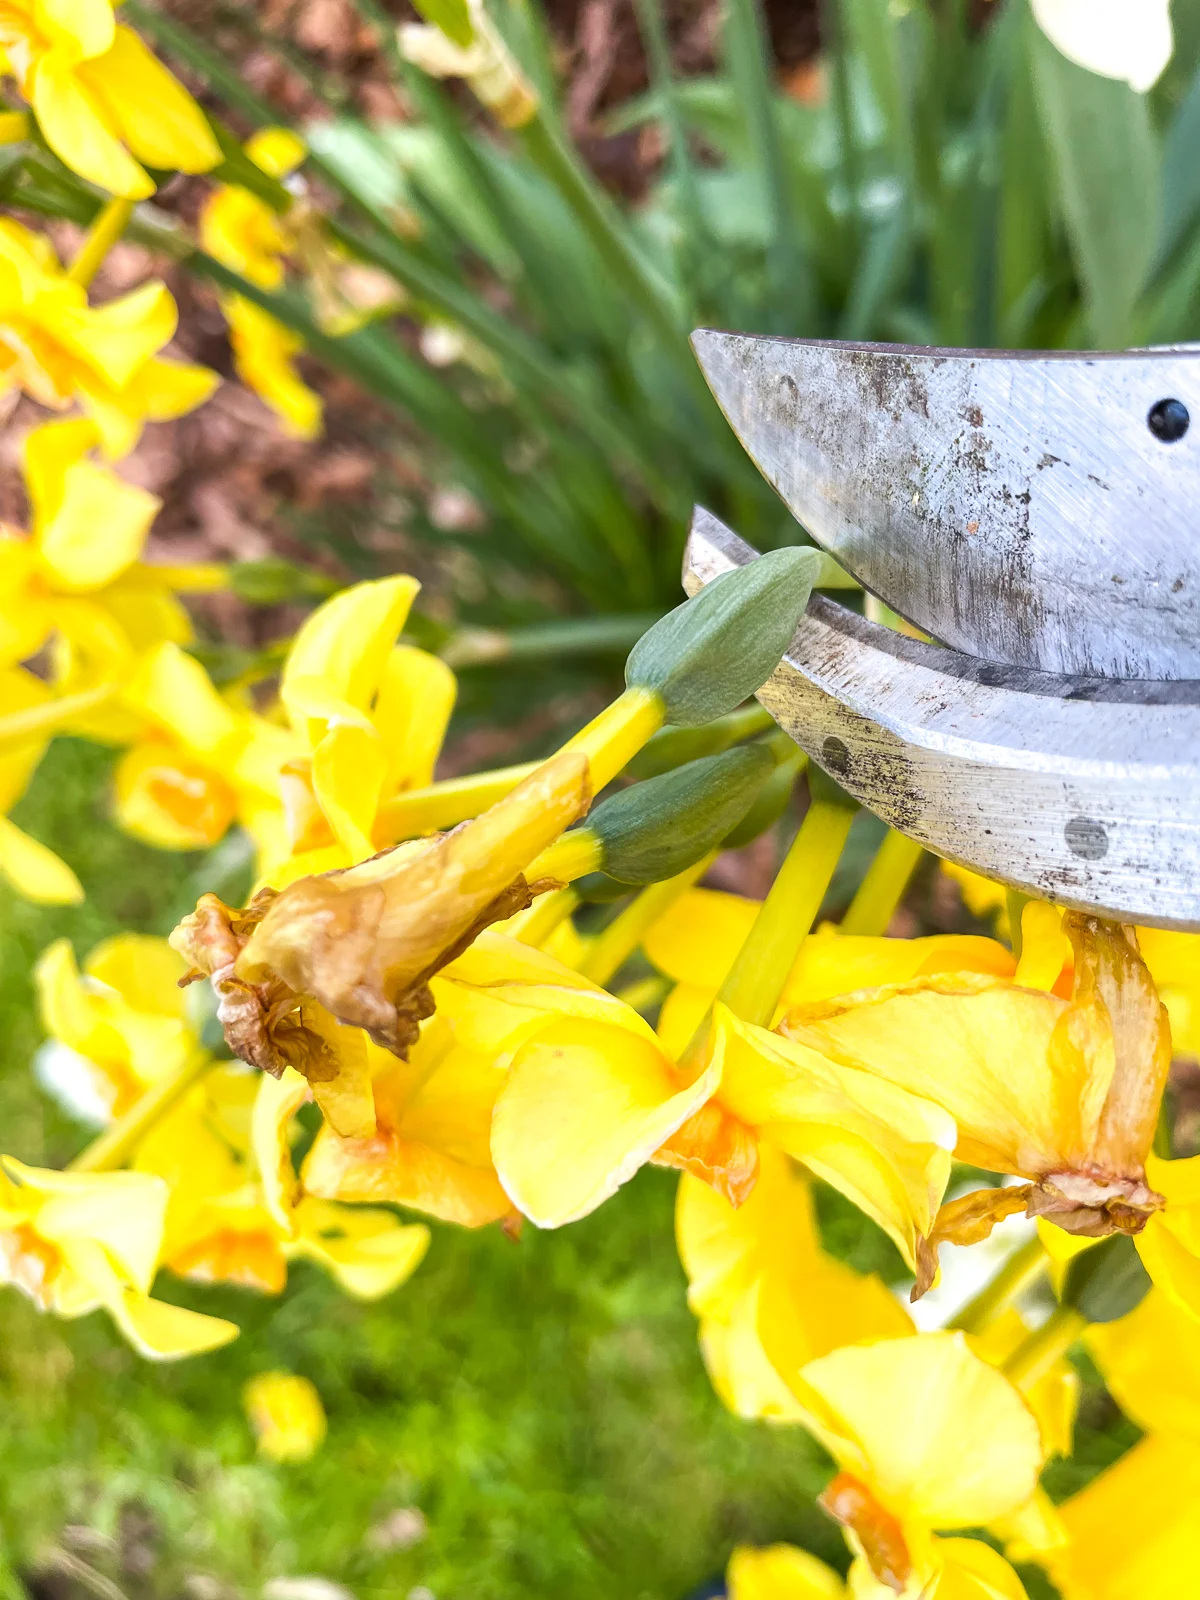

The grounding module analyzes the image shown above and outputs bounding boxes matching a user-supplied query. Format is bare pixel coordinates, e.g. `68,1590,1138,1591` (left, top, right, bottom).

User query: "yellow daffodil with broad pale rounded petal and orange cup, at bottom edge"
786,1333,1042,1600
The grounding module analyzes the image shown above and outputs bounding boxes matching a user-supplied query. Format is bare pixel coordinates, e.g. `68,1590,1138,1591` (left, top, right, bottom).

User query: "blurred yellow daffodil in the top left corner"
0,0,221,200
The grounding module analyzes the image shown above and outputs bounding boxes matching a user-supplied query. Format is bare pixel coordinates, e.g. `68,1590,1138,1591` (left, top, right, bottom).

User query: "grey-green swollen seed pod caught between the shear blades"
626,549,821,728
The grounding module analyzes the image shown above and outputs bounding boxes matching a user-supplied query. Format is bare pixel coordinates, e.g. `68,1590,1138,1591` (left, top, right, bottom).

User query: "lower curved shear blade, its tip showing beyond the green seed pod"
683,509,1200,930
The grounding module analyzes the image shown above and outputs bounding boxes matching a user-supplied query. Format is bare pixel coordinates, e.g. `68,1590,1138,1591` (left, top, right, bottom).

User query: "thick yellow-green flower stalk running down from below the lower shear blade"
710,798,854,1053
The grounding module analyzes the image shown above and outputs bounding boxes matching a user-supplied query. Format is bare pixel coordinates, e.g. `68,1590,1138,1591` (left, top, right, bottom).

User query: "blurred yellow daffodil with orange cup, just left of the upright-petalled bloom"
115,640,301,854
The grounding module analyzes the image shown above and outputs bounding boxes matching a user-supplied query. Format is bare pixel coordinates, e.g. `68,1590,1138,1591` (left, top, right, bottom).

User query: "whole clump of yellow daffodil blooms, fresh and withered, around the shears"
0,15,1200,1600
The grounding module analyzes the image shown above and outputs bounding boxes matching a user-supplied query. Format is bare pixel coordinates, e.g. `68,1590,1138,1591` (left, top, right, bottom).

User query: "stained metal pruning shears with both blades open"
685,339,1200,930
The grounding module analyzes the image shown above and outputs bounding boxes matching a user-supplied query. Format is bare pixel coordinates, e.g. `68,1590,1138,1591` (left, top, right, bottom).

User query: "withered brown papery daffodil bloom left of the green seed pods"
171,754,590,1083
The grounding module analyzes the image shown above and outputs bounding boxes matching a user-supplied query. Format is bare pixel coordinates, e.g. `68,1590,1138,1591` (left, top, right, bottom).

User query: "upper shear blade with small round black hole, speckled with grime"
693,330,1200,678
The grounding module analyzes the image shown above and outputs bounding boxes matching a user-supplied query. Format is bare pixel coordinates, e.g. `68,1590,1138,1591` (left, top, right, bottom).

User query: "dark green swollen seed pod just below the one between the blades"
587,744,774,883
